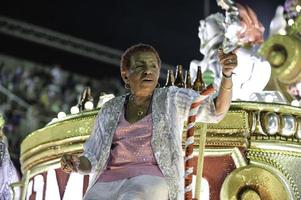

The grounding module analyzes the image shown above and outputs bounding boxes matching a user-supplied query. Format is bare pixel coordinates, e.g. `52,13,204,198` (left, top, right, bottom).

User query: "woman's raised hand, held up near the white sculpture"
218,49,237,78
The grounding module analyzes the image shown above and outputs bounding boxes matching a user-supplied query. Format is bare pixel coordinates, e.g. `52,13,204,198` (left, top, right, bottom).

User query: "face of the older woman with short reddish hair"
123,52,160,96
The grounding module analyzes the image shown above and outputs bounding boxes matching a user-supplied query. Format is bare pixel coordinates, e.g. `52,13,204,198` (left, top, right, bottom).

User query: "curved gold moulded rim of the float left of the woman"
20,110,98,172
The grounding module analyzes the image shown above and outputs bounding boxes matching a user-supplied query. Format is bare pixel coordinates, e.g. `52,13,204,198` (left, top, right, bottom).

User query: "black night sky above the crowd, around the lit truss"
0,0,284,78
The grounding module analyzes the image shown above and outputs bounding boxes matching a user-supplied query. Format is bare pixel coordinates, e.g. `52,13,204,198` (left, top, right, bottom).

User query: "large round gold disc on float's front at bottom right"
220,165,289,200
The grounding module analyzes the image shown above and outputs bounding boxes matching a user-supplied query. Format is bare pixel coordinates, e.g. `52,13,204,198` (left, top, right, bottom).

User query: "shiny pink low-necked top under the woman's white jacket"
98,110,164,182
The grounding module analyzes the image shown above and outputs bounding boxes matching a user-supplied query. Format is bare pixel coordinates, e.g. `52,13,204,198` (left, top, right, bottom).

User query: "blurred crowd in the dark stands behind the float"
0,55,124,173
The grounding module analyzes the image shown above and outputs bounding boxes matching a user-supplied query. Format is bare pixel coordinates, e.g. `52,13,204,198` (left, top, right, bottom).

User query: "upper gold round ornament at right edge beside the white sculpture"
259,34,301,101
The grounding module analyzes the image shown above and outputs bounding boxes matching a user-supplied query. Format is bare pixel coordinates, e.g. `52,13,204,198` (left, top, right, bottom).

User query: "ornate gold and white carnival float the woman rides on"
4,1,301,200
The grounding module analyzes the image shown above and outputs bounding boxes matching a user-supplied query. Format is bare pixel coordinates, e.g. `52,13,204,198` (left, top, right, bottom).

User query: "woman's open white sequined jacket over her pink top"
83,86,223,200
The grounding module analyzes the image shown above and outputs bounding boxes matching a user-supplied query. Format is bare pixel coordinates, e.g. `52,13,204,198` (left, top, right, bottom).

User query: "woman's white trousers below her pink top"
84,175,168,200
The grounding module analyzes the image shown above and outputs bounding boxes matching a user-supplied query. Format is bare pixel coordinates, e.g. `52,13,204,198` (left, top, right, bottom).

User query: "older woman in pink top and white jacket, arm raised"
61,44,237,200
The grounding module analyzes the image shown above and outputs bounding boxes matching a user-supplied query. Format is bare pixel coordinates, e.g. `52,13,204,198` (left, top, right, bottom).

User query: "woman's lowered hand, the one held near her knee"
61,154,80,173
